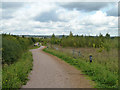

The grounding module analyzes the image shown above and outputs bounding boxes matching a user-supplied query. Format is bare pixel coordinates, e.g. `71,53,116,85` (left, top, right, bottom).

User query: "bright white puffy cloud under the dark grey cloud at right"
79,11,118,27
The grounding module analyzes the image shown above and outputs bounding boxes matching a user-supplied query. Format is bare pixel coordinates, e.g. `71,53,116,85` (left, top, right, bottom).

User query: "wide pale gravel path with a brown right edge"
22,46,92,88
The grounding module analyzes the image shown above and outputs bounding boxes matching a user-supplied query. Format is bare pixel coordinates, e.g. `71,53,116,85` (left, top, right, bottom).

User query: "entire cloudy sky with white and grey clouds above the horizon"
0,2,118,36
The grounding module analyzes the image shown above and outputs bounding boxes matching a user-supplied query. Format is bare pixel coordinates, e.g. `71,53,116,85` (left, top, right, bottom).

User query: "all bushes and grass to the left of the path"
2,34,39,88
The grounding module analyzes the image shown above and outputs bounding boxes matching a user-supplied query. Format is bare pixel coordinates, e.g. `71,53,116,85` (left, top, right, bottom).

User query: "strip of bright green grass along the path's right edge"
43,49,118,88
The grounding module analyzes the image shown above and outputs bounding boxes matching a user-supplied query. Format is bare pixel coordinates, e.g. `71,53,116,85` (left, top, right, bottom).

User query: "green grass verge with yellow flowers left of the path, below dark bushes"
2,51,33,88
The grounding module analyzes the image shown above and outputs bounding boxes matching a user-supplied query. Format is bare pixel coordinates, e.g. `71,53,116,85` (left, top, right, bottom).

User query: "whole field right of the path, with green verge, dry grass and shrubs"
42,32,119,88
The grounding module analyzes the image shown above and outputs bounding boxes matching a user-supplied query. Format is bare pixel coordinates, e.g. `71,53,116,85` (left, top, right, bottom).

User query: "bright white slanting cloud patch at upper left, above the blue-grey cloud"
13,2,56,19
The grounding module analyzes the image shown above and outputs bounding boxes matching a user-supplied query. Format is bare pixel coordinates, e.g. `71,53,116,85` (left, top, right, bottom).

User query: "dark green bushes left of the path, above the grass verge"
2,34,38,65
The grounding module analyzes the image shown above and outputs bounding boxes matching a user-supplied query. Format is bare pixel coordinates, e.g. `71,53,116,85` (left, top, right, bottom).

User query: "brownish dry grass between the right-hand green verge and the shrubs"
49,45,118,73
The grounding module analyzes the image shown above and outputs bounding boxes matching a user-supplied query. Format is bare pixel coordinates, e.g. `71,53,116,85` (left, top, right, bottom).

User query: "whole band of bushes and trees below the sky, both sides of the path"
2,32,119,64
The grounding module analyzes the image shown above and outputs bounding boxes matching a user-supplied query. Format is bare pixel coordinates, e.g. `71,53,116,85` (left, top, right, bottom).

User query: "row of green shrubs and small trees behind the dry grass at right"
42,32,119,51
